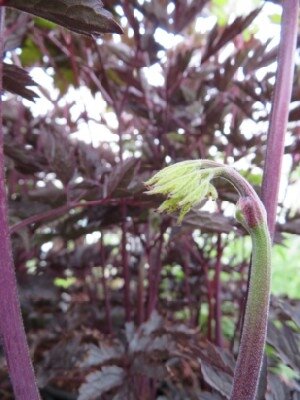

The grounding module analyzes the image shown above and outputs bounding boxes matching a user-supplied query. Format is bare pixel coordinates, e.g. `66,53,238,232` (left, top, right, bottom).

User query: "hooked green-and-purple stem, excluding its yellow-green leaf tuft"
204,162,272,400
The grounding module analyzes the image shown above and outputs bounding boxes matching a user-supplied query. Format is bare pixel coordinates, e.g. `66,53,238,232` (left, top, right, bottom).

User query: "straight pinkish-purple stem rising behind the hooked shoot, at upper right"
262,0,299,238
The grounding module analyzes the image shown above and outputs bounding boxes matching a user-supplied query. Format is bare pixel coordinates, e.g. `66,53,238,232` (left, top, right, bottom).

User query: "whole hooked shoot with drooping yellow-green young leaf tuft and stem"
146,160,271,400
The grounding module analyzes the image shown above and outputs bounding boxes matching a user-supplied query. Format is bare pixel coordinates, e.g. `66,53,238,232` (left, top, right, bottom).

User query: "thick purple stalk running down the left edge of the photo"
0,7,40,400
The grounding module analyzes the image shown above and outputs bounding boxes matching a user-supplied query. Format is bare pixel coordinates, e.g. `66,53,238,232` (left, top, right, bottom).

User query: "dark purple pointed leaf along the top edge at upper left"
5,0,122,35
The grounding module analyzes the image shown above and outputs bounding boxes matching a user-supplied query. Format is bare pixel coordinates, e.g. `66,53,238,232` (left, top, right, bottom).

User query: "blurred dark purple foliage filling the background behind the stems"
0,0,300,400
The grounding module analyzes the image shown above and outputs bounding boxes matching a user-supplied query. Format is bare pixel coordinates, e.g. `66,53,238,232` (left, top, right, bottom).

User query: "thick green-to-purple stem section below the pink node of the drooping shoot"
230,221,271,400
